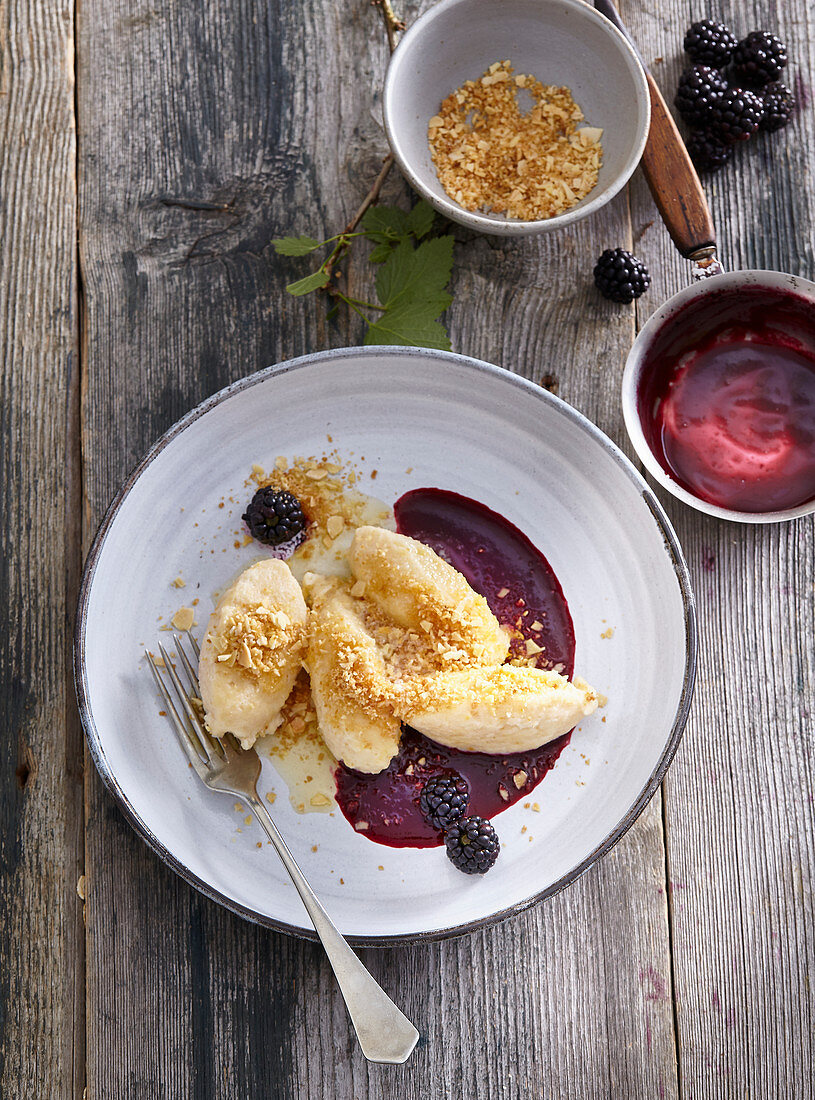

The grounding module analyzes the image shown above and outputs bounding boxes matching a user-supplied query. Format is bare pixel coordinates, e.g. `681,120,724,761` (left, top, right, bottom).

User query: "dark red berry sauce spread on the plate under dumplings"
337,488,574,848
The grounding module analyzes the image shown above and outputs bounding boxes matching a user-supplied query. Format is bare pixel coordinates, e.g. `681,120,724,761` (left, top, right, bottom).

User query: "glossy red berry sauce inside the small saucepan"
638,286,815,513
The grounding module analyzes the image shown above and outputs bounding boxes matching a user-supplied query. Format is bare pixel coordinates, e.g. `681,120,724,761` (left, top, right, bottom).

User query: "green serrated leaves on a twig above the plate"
272,199,453,351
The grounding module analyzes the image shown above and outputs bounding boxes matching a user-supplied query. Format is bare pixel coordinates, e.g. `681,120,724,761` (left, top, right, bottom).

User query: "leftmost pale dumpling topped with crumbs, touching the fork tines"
198,558,308,748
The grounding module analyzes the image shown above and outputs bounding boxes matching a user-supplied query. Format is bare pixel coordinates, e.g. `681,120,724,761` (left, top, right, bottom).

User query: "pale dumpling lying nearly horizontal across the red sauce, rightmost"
404,664,597,754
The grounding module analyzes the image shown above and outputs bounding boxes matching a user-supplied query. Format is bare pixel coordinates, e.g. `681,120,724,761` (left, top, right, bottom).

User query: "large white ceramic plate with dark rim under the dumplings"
76,348,696,943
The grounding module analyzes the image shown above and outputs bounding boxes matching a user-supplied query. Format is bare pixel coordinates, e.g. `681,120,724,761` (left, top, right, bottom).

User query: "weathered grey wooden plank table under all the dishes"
0,0,815,1100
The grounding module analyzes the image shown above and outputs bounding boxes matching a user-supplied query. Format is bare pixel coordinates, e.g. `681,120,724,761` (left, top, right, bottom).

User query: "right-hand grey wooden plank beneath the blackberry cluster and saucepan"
626,0,815,1100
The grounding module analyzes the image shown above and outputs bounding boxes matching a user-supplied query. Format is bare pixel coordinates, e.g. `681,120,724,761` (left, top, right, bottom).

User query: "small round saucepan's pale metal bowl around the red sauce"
623,271,815,524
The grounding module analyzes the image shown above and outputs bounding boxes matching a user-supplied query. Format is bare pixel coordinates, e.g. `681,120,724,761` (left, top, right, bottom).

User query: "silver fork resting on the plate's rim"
147,630,419,1065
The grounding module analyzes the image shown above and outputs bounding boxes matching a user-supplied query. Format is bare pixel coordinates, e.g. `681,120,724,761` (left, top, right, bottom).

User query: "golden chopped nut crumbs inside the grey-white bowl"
428,61,603,221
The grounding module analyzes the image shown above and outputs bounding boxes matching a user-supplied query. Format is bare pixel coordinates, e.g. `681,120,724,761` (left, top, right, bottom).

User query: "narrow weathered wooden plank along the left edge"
0,0,85,1100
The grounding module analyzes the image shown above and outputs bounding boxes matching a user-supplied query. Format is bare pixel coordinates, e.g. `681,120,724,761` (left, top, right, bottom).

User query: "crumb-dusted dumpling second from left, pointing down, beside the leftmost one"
306,576,401,772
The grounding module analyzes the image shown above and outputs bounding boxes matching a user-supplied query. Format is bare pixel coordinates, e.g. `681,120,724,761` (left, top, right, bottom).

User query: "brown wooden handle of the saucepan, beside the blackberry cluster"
642,73,716,259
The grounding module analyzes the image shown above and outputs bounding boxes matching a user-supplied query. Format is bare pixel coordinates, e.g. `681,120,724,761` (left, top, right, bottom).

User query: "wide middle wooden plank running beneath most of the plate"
79,0,676,1100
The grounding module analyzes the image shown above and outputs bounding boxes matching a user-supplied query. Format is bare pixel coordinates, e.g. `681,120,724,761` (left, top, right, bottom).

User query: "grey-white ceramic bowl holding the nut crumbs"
384,0,651,237
